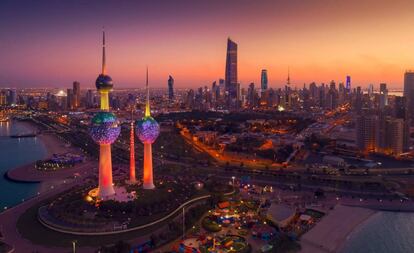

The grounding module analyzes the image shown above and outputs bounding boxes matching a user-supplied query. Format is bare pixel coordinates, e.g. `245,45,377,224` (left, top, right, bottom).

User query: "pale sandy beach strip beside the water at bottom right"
300,205,376,253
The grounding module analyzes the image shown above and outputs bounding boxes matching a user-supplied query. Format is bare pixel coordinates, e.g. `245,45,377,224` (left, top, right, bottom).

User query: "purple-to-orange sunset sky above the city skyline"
0,0,414,88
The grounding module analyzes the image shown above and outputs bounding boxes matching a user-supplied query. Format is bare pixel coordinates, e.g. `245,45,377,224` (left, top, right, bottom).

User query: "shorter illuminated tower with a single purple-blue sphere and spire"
136,68,160,189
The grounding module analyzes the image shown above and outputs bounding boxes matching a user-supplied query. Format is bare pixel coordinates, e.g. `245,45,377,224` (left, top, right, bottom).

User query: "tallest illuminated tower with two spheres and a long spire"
89,31,121,199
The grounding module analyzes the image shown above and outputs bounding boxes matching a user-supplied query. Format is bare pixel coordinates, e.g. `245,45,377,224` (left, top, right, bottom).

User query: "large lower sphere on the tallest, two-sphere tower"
89,112,121,144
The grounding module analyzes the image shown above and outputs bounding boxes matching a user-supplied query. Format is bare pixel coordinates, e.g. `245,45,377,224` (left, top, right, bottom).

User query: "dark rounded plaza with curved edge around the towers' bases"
38,178,220,235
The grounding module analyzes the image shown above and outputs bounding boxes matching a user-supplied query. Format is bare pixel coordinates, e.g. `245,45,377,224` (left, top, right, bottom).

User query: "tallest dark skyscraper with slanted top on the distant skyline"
225,38,237,99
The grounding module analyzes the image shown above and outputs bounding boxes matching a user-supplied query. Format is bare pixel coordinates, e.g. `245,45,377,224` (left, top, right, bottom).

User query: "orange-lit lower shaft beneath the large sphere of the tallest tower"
98,144,115,199
